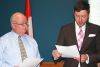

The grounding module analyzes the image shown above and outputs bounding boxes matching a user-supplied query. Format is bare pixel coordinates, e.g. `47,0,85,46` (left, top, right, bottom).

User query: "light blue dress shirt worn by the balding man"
0,31,40,67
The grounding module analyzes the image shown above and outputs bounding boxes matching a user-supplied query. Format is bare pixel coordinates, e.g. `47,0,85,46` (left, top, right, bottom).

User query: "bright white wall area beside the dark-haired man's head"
89,0,100,25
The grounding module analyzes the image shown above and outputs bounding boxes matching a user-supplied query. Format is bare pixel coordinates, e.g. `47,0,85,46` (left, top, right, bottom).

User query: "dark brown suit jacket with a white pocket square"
57,23,100,67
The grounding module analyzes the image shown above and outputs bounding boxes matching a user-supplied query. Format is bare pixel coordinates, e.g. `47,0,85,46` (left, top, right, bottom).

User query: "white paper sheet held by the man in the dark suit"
56,45,80,58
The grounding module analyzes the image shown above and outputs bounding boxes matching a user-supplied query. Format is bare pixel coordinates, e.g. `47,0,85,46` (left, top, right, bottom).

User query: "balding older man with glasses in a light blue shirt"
0,12,40,67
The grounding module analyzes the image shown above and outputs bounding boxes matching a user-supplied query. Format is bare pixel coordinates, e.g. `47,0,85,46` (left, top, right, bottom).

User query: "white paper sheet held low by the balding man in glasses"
20,58,43,67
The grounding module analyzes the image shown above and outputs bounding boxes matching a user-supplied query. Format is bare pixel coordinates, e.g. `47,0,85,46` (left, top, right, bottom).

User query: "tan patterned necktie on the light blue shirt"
18,36,27,61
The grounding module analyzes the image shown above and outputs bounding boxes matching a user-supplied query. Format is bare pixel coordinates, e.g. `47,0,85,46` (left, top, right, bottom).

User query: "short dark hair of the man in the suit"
74,0,90,13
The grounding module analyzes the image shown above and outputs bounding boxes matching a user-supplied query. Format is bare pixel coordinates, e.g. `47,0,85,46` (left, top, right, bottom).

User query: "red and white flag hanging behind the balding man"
25,0,33,37
